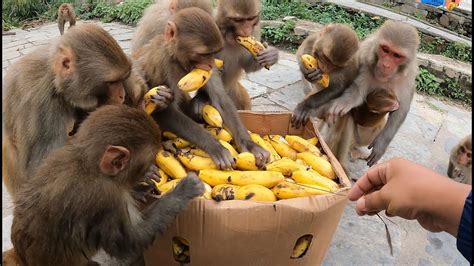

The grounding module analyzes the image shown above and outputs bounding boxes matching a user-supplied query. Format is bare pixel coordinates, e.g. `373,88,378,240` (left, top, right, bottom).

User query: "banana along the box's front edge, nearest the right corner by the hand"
272,181,329,199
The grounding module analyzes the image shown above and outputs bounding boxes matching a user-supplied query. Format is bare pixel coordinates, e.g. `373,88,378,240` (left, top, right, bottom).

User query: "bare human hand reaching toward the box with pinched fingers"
348,158,472,237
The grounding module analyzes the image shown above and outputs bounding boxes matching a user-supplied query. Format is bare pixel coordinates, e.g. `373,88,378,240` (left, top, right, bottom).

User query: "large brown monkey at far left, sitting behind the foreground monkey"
2,23,172,199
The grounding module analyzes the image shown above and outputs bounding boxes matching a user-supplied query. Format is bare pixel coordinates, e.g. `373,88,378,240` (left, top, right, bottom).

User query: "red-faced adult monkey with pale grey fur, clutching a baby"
323,20,420,166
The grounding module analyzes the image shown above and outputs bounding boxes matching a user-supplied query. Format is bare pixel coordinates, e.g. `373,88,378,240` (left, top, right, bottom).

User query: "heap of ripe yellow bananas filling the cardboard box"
145,105,339,202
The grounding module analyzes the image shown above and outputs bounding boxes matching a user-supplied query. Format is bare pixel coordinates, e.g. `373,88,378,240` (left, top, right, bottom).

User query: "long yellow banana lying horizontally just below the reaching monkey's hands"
199,169,285,188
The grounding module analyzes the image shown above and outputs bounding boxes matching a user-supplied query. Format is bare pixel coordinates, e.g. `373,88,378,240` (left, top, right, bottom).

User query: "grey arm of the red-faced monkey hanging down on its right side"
367,88,414,166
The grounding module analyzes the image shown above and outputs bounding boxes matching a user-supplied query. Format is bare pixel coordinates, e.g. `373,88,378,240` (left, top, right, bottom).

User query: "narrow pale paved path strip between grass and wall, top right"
327,0,472,46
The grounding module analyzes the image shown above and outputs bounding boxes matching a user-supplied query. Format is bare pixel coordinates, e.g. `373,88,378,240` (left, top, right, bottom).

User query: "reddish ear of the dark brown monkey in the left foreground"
100,146,130,176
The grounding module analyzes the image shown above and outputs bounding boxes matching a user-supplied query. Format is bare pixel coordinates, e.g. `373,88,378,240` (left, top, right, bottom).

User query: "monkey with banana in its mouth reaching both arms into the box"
134,7,269,169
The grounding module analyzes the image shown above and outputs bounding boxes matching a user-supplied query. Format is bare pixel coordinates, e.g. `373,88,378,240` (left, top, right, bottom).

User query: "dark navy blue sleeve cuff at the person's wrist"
456,190,472,263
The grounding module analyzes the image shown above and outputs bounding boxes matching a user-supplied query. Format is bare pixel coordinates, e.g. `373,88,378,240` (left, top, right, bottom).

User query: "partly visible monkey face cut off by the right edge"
448,134,472,185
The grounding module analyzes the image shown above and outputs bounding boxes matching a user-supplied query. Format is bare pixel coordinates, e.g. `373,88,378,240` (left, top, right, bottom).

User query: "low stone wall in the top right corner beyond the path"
359,0,472,38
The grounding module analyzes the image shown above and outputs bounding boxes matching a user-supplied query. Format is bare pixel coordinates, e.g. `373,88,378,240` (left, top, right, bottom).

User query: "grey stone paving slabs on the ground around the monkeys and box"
2,21,472,265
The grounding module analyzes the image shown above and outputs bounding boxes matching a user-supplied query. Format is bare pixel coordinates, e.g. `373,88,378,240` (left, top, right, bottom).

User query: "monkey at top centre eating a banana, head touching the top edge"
216,0,278,110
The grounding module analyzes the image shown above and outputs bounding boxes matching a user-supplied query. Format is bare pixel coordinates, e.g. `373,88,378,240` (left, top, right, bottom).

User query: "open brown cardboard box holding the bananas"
145,111,351,266
